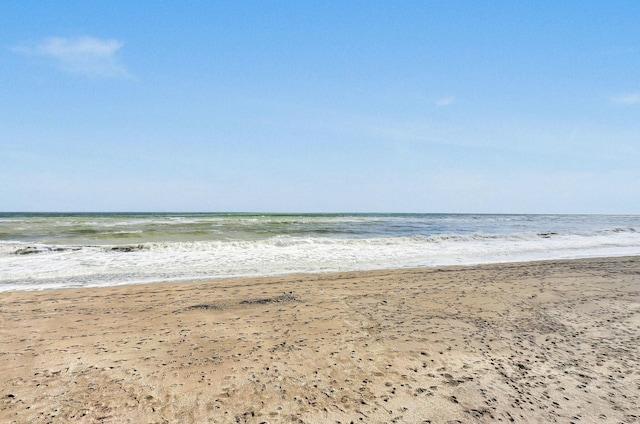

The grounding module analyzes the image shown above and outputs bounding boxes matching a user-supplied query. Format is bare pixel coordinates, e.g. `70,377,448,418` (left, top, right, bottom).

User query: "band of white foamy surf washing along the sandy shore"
0,227,640,291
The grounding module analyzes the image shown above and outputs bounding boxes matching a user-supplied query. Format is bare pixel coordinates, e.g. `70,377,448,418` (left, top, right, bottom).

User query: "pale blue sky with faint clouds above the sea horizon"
0,1,640,213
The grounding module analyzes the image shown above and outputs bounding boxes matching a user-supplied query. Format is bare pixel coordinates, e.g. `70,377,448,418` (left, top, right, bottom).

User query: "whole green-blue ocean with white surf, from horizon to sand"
0,213,640,291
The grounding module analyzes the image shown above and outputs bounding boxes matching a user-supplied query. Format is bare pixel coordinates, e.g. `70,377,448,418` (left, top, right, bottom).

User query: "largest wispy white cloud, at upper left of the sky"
12,37,132,78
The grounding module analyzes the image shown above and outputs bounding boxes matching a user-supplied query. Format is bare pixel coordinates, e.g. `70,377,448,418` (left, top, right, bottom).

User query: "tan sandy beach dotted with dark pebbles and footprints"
0,257,640,423
